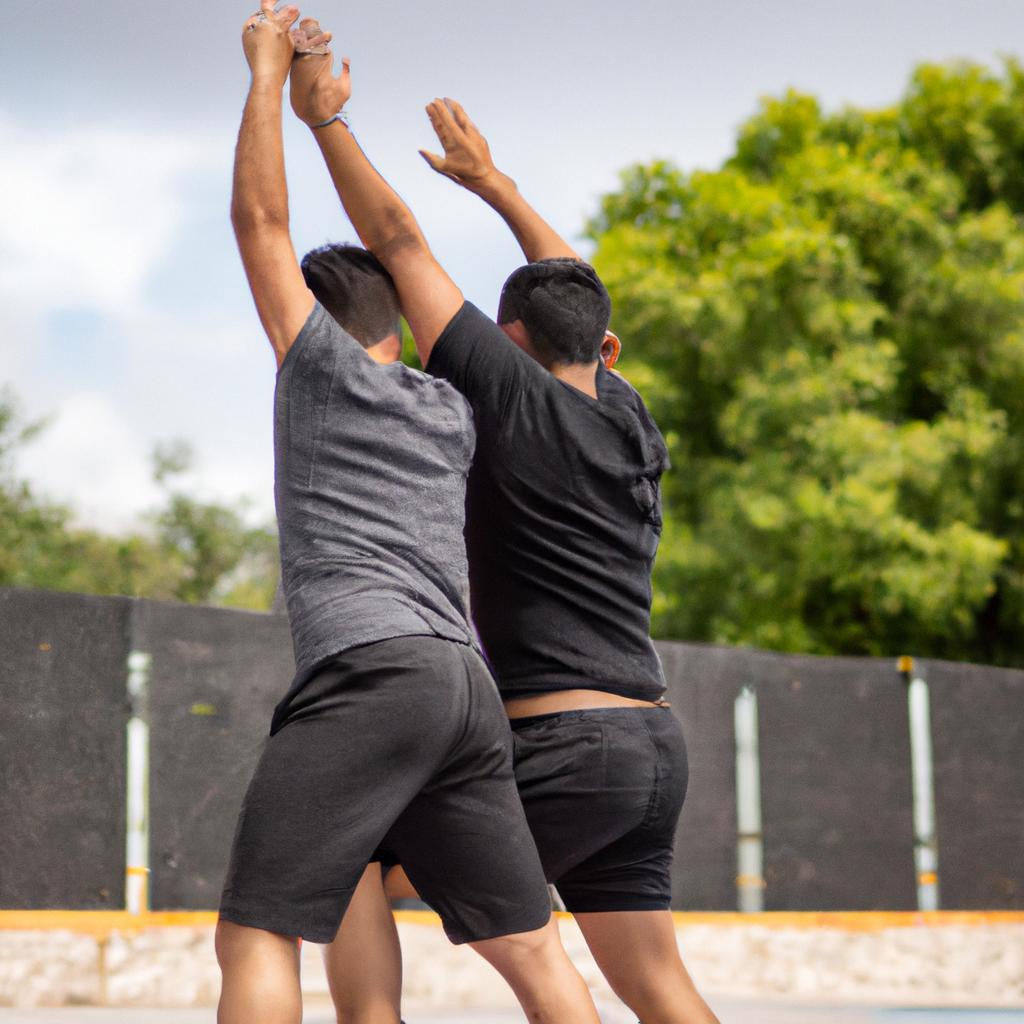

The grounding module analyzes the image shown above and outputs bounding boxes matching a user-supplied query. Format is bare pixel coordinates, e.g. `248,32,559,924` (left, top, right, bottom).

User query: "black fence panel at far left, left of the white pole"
0,590,131,910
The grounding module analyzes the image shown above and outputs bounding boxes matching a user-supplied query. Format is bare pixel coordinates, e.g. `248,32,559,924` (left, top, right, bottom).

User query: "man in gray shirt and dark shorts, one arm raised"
217,8,598,1024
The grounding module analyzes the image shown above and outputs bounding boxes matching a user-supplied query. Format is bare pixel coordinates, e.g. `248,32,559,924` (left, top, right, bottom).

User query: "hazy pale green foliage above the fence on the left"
0,395,278,609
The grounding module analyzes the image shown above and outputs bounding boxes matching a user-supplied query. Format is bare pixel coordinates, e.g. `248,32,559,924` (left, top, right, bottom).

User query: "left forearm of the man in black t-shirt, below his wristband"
313,122,427,266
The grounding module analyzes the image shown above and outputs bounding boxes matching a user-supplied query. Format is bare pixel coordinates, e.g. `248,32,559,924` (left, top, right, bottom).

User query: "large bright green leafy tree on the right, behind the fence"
591,61,1024,665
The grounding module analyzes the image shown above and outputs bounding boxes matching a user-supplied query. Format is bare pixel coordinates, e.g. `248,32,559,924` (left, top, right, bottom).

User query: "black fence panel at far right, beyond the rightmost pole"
923,662,1024,910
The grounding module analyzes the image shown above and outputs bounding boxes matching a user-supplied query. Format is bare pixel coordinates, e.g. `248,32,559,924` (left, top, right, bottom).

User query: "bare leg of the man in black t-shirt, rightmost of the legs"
575,910,719,1024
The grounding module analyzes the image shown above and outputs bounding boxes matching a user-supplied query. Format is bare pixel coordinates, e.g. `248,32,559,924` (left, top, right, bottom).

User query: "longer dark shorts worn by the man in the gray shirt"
220,636,551,942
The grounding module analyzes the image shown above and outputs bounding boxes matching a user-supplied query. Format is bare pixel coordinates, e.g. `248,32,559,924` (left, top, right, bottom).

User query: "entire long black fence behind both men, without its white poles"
0,590,1024,910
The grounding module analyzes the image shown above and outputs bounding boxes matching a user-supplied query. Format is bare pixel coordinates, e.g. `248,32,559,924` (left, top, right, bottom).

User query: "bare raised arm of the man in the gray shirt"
231,0,313,366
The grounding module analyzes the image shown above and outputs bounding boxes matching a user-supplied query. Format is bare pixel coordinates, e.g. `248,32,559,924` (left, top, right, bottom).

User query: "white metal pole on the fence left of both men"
125,650,153,913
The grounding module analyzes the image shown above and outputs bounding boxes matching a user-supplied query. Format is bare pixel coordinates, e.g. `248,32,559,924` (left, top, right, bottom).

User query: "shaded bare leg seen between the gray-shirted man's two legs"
324,864,401,1024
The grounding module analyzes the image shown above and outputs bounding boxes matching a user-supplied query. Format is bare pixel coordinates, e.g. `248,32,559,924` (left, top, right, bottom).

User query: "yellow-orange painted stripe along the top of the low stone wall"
0,910,1024,935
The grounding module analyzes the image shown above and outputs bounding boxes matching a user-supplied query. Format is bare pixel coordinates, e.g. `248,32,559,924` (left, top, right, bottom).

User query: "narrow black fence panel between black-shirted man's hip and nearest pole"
657,643,750,910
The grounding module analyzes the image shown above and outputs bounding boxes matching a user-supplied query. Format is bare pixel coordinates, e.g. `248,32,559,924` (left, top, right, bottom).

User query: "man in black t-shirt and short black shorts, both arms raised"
292,24,716,1024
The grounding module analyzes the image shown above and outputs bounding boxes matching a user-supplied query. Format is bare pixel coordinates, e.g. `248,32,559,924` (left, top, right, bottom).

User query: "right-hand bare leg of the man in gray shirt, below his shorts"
472,918,600,1024
